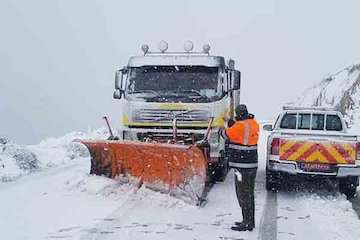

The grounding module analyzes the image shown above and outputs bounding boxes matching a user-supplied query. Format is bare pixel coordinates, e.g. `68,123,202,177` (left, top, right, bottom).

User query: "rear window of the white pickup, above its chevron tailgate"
280,113,343,131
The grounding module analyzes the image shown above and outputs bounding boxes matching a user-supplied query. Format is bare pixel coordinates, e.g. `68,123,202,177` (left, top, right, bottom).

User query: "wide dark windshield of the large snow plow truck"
126,66,221,102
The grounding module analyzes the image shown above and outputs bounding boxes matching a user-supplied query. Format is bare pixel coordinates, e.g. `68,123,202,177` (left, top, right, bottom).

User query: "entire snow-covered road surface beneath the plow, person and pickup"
0,129,360,240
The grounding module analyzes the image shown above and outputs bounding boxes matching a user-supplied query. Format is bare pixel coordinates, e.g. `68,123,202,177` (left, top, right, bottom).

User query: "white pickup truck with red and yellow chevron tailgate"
263,107,360,198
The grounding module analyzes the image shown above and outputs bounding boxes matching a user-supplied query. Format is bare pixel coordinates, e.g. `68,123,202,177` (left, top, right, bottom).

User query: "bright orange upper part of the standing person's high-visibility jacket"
226,119,259,146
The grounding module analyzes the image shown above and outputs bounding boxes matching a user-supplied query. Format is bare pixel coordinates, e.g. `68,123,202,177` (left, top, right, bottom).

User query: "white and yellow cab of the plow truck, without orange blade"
114,42,241,180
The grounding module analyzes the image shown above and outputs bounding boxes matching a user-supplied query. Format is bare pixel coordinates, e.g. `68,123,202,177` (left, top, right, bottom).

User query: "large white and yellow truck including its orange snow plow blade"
82,41,241,204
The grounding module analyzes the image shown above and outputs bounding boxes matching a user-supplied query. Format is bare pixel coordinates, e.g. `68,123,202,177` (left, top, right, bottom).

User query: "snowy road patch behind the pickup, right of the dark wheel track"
277,181,360,240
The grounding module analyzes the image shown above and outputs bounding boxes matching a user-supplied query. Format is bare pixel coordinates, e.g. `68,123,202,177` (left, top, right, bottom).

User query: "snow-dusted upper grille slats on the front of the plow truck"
133,109,210,123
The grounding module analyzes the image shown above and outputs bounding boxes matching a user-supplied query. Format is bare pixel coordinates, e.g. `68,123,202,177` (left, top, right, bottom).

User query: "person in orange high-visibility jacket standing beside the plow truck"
221,104,259,231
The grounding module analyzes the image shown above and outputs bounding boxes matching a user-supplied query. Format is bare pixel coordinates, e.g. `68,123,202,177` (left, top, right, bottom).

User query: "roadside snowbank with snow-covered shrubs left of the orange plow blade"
0,128,108,182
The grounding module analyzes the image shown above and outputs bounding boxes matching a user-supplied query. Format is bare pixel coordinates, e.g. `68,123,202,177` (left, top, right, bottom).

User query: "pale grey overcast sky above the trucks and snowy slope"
0,0,360,143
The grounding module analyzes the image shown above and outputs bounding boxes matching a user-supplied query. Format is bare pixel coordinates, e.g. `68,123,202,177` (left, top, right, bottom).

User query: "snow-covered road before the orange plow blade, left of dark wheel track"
0,159,265,239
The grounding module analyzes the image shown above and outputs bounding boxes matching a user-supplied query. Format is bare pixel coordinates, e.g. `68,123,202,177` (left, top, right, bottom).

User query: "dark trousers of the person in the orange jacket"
234,168,257,227
